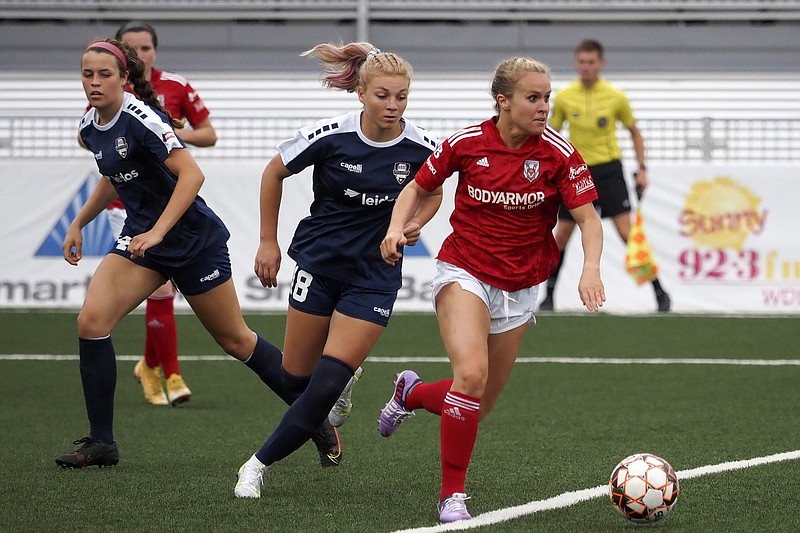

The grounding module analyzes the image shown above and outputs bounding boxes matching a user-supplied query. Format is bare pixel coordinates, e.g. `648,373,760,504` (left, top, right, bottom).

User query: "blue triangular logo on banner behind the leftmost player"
36,171,116,257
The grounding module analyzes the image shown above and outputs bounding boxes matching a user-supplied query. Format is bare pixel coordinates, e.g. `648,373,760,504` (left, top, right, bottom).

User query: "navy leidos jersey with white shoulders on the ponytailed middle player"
278,111,437,290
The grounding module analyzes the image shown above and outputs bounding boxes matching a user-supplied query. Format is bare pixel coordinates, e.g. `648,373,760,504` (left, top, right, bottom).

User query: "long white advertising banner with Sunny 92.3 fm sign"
0,159,800,314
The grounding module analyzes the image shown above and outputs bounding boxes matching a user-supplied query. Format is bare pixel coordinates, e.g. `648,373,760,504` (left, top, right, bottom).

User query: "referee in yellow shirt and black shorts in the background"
539,40,671,312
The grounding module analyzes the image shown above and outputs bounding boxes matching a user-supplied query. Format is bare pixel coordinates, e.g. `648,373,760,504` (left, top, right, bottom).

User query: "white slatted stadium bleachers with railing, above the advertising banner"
0,73,800,164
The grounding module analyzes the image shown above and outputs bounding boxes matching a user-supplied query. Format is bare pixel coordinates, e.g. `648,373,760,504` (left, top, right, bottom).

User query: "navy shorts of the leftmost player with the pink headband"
109,240,231,296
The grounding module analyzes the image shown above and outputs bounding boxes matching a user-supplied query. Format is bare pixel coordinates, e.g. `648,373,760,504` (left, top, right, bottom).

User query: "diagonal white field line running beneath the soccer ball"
393,450,800,533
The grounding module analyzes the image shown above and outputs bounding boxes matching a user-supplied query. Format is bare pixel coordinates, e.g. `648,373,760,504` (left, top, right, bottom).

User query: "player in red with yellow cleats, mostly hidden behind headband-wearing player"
108,20,217,405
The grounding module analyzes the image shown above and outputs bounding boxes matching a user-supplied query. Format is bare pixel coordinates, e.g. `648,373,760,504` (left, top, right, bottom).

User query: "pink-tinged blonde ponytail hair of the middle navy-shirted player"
300,42,413,93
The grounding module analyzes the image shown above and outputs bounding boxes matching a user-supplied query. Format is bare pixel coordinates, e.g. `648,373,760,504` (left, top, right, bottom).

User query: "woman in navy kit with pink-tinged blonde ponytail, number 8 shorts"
234,43,441,498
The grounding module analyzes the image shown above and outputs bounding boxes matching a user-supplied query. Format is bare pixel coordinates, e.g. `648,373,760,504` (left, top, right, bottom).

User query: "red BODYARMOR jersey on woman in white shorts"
414,119,597,291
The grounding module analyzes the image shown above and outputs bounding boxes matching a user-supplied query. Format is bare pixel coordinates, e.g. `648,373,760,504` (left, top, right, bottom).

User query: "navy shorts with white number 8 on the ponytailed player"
289,266,397,327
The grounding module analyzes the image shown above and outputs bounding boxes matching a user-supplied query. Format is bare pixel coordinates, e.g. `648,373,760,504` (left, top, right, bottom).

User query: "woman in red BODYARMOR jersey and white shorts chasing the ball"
378,57,605,522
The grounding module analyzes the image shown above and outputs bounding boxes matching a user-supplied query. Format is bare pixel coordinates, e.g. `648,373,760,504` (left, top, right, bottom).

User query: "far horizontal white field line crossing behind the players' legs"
0,354,800,366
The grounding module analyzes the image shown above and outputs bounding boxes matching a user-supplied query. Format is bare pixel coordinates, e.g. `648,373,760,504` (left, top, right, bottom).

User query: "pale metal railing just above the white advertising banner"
0,116,800,165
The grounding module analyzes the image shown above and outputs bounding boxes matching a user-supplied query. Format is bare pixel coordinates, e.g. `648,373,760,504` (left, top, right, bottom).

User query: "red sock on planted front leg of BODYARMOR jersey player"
439,391,481,500
